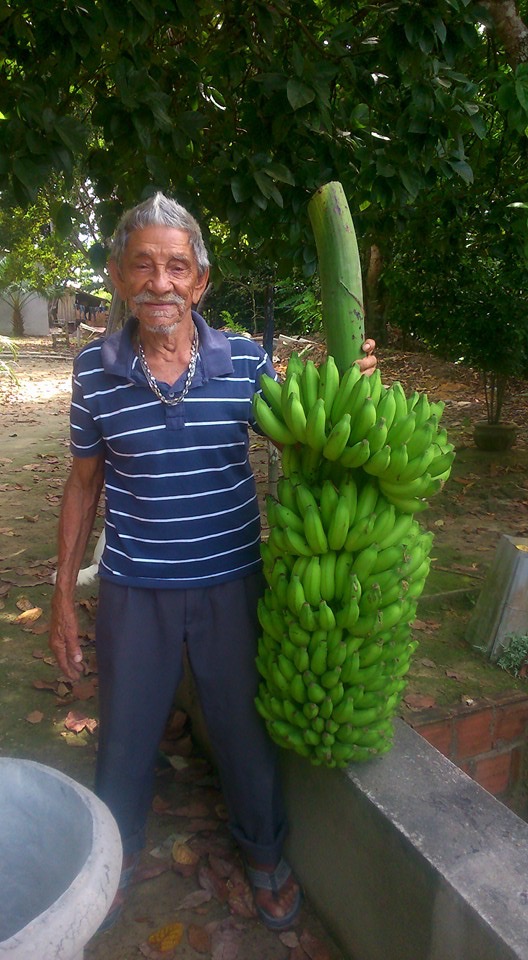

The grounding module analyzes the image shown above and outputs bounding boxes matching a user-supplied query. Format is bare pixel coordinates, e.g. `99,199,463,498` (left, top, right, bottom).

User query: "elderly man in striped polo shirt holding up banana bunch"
50,193,376,929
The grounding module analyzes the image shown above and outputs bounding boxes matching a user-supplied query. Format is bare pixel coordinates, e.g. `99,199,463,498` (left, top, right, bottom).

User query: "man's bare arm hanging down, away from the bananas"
49,454,104,680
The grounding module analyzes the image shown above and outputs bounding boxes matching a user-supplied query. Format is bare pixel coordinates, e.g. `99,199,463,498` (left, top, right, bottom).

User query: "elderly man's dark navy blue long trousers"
95,574,286,864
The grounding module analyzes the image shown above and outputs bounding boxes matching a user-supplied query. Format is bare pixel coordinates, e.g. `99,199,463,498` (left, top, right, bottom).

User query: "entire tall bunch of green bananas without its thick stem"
254,354,454,766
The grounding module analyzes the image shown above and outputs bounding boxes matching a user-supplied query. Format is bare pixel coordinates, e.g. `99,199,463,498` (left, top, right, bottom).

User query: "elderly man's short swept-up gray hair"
110,191,209,276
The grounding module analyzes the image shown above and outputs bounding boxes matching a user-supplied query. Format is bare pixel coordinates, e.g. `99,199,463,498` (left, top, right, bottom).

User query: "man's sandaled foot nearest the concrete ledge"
246,859,302,930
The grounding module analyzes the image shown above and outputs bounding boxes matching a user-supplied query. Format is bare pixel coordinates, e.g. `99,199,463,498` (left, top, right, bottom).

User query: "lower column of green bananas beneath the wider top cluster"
256,475,433,766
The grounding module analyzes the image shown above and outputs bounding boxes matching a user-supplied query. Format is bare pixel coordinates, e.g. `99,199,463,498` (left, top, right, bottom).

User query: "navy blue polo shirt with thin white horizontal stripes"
71,313,275,589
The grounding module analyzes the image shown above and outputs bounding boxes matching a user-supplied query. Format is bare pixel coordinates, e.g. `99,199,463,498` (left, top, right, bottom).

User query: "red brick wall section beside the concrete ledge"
404,693,528,816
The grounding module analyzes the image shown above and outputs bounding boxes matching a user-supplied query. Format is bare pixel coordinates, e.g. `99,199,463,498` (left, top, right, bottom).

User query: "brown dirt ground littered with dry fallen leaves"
0,338,528,960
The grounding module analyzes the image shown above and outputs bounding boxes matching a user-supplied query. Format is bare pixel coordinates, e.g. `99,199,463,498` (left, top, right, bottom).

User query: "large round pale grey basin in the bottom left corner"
0,757,122,960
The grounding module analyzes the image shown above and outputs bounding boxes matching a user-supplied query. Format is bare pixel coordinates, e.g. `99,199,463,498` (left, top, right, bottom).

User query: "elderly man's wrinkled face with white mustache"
108,226,209,334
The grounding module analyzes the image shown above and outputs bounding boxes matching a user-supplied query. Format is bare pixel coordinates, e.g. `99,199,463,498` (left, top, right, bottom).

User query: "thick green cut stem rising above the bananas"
308,182,365,374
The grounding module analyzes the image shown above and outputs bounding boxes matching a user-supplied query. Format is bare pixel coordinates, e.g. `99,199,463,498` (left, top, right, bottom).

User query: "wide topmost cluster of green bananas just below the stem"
254,354,455,513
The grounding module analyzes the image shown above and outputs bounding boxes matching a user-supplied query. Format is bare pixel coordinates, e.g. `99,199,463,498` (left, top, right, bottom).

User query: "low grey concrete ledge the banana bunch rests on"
283,720,528,960
